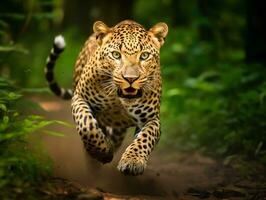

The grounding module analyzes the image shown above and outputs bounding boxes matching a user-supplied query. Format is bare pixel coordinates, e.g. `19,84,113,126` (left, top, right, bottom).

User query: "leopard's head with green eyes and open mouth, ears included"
93,20,168,99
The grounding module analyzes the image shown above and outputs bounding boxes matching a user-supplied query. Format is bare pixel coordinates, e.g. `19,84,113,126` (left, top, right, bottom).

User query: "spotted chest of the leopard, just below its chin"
89,92,159,128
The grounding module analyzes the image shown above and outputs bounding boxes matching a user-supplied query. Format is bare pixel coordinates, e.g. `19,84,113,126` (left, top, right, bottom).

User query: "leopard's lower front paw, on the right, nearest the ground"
117,155,147,176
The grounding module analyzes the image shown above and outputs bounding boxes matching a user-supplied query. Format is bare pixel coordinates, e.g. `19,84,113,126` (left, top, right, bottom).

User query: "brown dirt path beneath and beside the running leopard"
30,97,266,200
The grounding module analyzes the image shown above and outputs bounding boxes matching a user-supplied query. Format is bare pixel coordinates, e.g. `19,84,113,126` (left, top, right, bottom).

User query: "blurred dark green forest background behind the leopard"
0,0,266,195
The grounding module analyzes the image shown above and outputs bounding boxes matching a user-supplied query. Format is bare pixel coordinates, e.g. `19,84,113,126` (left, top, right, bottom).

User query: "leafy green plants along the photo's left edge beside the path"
0,1,69,194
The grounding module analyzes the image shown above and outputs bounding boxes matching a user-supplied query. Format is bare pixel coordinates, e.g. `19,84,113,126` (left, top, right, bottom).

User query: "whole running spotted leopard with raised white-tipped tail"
45,20,168,176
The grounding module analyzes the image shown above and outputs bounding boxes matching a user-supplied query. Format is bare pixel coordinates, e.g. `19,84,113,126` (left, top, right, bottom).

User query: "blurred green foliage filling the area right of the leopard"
149,0,266,162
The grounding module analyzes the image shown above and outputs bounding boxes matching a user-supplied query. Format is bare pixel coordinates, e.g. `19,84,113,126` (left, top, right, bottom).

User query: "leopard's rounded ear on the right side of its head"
149,22,168,48
